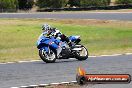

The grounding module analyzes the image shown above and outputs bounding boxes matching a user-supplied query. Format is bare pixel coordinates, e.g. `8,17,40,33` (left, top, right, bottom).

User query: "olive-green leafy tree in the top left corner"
0,0,18,12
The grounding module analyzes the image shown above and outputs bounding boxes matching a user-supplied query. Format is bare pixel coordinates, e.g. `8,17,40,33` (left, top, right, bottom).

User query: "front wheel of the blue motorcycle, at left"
39,50,56,63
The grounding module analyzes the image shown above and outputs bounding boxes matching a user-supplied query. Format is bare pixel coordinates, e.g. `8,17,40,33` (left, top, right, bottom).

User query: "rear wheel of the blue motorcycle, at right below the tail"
76,45,88,61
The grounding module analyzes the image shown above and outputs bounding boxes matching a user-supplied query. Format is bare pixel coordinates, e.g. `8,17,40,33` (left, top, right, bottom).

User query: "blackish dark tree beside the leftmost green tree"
18,0,34,10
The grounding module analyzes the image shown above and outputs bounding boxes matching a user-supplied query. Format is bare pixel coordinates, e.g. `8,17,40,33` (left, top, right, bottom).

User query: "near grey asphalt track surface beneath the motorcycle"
0,55,132,88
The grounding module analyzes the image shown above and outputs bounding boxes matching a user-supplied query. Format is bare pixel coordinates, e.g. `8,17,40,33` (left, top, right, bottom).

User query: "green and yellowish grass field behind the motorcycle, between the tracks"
0,19,132,62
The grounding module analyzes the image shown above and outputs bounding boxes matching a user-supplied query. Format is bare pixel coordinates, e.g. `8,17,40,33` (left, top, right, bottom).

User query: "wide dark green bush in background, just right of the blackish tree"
36,0,68,8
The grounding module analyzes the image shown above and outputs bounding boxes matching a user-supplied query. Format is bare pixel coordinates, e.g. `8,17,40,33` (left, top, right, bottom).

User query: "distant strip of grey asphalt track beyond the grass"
0,12,132,21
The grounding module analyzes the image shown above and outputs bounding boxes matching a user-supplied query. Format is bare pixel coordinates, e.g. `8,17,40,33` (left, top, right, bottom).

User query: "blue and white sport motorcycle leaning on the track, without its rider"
37,36,88,63
